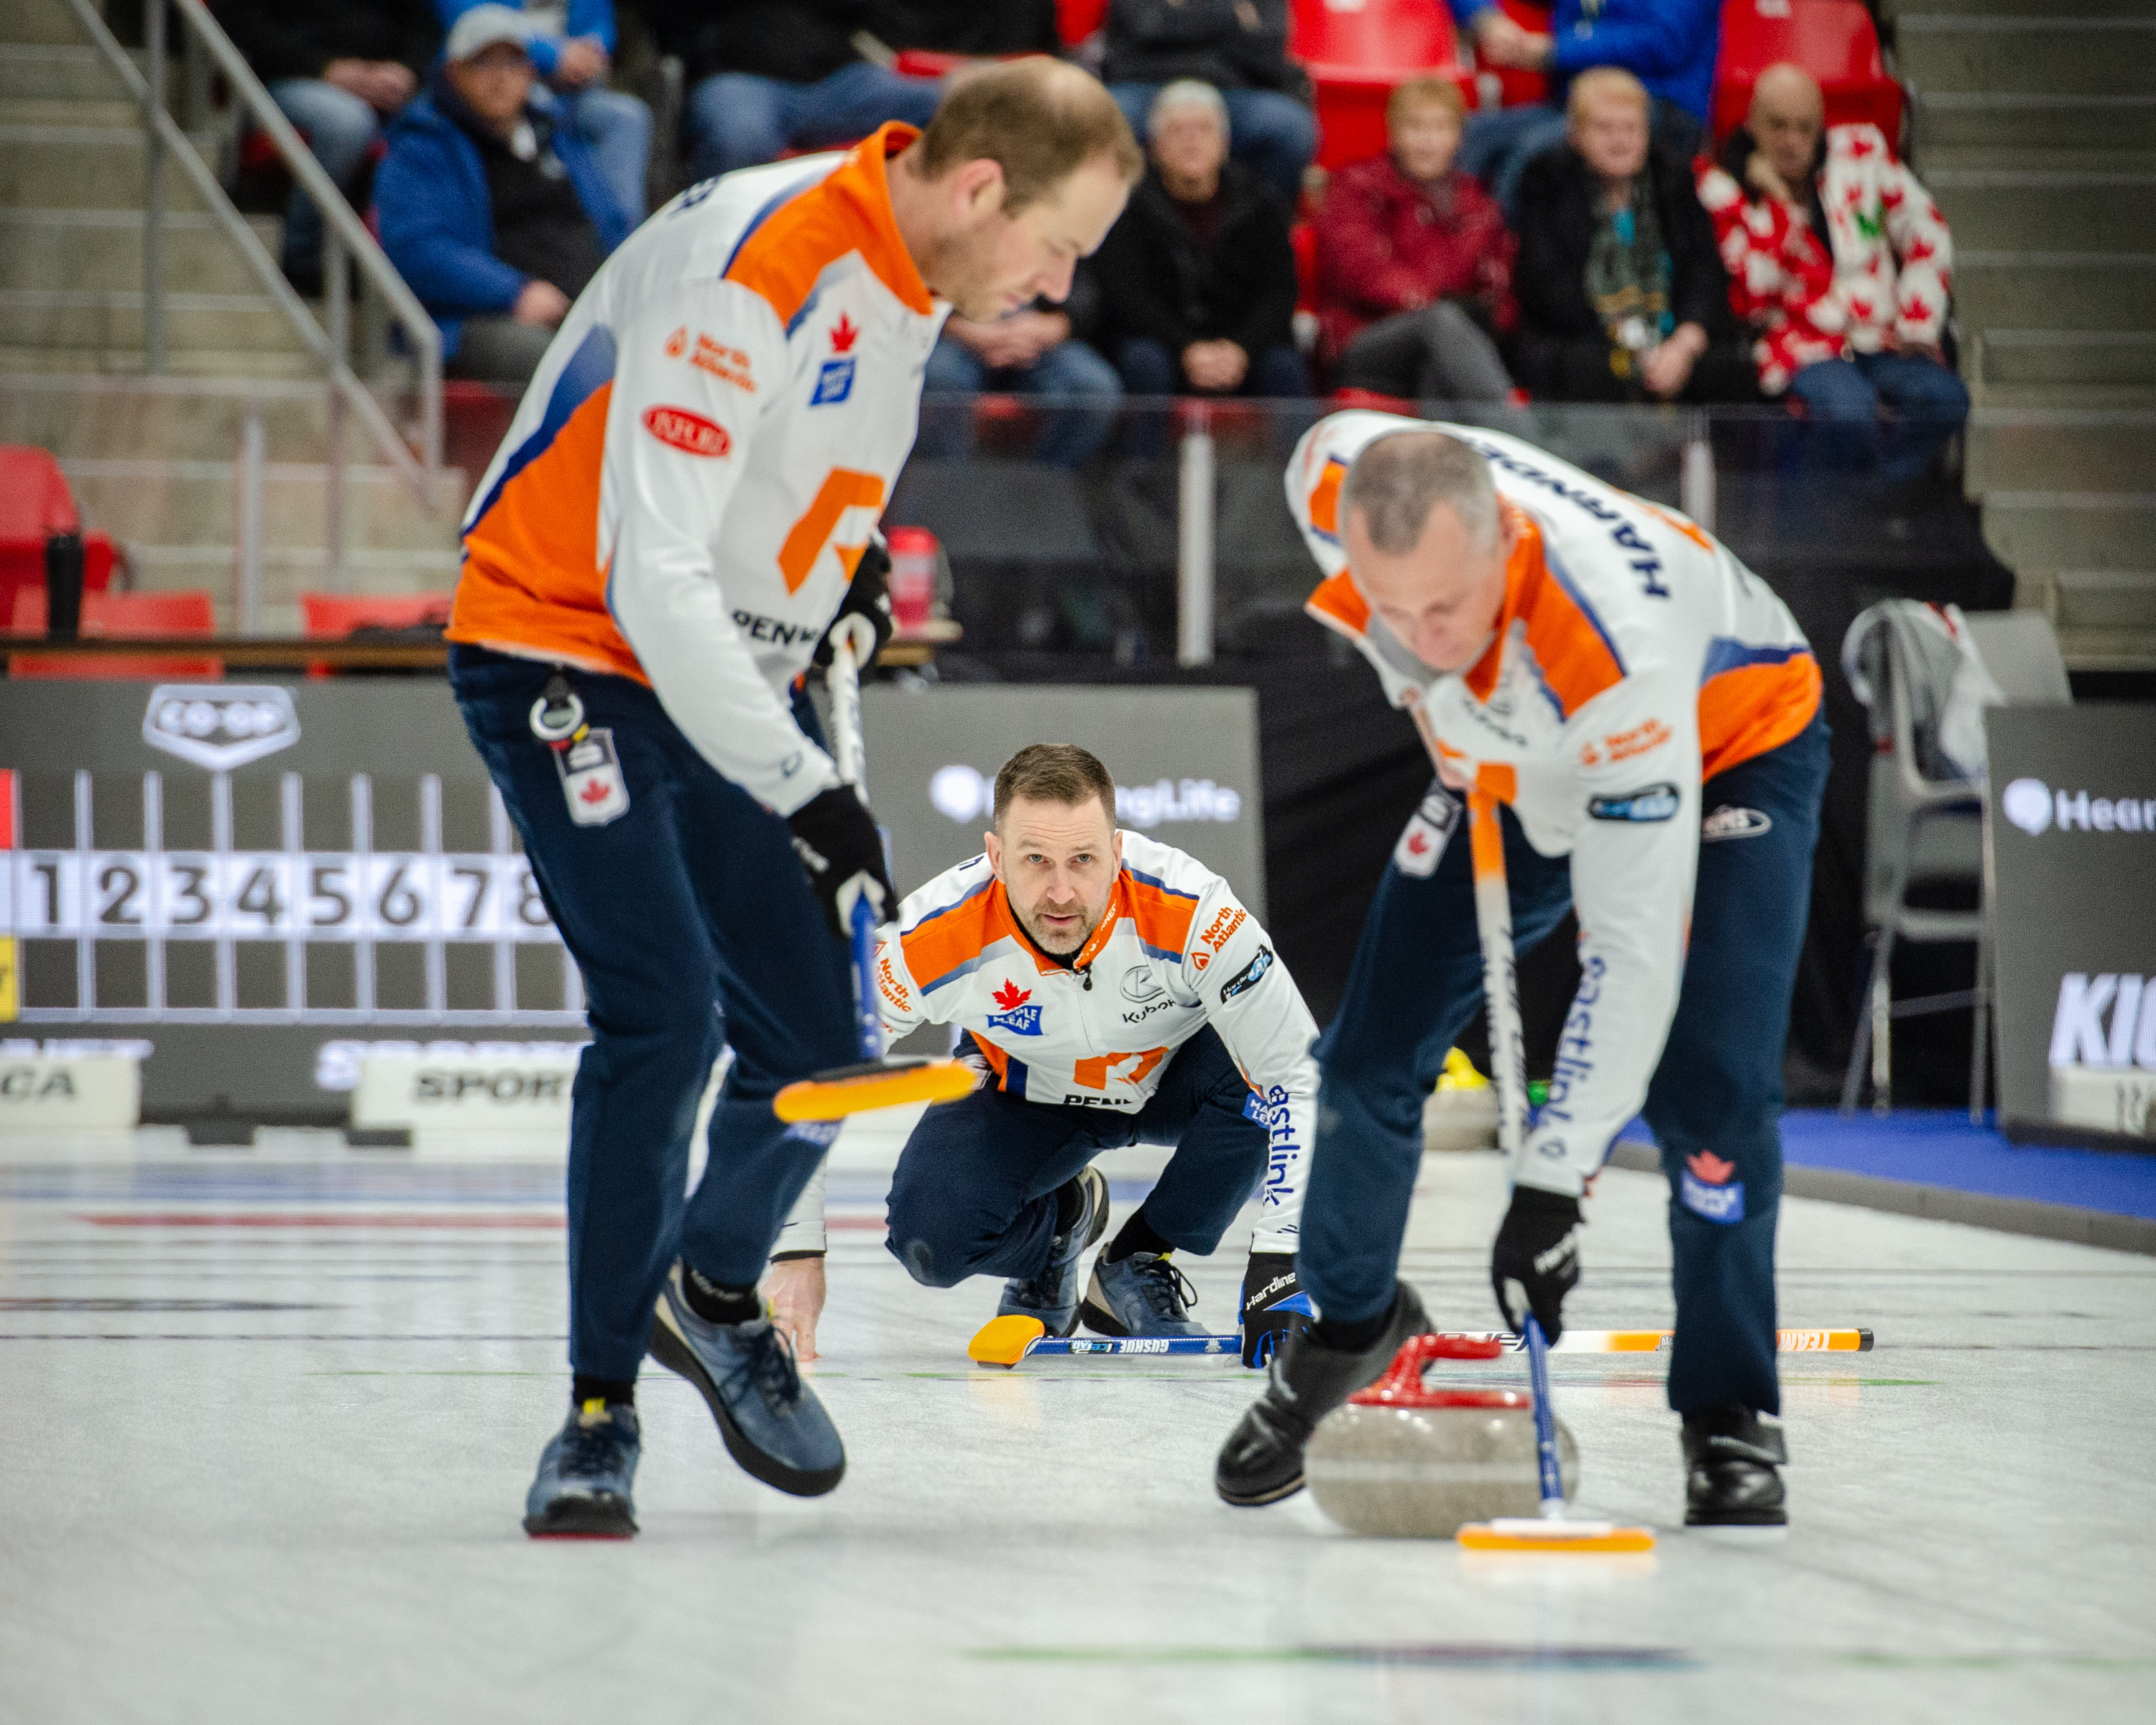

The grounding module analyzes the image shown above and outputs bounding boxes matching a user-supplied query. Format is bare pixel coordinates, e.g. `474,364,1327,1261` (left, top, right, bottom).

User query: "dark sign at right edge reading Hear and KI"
1986,705,2156,1141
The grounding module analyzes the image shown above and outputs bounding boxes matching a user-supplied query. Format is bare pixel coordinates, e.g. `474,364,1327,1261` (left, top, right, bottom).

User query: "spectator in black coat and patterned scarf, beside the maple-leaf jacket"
1514,67,1757,401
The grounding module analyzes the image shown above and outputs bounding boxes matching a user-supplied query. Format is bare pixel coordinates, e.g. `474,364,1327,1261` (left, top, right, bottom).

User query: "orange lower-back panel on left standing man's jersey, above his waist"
446,384,649,681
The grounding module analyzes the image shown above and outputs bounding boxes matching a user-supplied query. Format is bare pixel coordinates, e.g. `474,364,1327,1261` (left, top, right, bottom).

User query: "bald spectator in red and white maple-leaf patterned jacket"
1699,65,1968,485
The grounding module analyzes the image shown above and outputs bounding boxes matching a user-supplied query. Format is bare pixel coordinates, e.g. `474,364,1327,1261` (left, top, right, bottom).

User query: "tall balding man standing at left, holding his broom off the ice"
448,60,1141,1535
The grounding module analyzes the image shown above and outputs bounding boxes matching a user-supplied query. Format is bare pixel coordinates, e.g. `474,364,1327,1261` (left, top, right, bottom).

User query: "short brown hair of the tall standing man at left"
921,54,1145,216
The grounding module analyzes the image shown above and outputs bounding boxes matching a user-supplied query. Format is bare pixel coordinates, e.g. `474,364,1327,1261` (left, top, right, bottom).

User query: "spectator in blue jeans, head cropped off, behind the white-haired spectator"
1102,0,1317,209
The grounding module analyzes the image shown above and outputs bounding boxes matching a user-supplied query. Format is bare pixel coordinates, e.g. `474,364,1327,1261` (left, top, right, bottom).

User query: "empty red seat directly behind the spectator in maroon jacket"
1287,0,1475,168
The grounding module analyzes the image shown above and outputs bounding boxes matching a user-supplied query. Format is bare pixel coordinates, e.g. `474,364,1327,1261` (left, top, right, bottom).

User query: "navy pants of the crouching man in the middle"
888,1026,1272,1287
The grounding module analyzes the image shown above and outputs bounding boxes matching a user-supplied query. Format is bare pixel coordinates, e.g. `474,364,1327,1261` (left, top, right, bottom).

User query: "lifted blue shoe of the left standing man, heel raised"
649,1261,845,1496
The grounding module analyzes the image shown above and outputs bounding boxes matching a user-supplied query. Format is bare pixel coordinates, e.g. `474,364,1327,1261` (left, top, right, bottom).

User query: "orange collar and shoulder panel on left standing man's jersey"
727,121,936,332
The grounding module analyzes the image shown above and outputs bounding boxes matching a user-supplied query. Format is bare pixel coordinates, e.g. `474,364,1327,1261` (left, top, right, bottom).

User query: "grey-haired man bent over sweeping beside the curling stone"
1218,412,1826,1522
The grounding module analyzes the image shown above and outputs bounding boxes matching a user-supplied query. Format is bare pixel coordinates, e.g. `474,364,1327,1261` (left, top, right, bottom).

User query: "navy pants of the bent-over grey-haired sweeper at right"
1296,718,1826,1412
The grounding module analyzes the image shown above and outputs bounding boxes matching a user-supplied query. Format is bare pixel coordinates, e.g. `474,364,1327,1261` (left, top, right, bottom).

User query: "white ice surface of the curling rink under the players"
0,1121,2156,1725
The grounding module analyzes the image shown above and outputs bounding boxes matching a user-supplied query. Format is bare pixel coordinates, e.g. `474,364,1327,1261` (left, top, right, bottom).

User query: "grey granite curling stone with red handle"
1304,1335,1580,1540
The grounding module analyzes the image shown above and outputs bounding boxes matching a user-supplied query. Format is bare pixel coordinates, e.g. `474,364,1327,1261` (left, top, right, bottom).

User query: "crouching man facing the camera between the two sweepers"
772,744,1317,1365
